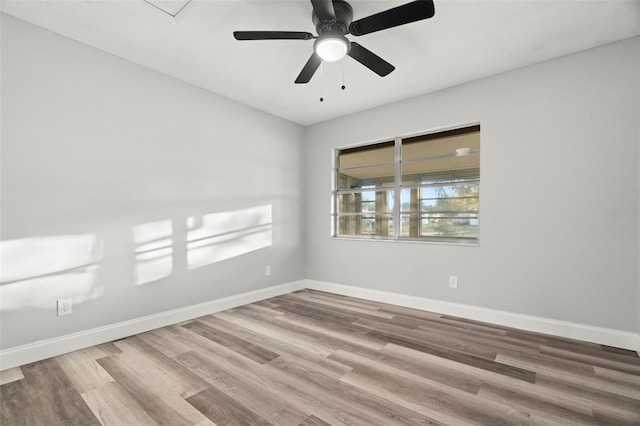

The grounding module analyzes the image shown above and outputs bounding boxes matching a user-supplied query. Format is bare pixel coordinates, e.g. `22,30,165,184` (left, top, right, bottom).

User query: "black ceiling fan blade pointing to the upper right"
349,0,435,36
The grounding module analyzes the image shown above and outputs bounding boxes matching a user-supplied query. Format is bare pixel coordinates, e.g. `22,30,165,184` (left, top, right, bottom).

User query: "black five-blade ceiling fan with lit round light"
233,0,435,83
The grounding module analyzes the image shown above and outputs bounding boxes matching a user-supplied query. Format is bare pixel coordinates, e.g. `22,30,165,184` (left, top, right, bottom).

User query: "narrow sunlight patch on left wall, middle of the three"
133,220,173,285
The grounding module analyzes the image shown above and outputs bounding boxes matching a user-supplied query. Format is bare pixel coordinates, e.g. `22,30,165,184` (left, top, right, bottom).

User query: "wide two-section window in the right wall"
333,126,480,243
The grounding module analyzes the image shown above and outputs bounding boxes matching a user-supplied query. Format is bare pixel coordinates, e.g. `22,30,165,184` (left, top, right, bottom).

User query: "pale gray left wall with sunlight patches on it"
0,15,305,349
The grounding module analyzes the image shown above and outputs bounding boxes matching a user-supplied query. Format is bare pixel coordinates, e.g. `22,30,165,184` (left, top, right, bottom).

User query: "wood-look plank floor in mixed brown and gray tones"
0,290,640,426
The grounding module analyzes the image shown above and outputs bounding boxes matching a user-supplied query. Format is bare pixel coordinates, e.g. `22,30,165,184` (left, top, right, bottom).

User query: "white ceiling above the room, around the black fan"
0,0,640,125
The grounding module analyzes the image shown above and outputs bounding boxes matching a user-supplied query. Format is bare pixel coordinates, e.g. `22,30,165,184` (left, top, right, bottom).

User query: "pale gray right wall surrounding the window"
305,38,640,332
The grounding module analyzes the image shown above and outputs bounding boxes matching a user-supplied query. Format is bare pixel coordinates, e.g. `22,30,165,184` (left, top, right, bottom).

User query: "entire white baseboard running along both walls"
0,280,640,370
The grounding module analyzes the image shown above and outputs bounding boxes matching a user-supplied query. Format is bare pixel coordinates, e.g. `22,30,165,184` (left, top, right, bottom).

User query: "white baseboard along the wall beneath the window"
305,280,640,355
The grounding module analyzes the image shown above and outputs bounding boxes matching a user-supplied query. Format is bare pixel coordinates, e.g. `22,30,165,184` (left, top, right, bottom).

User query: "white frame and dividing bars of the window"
331,123,481,246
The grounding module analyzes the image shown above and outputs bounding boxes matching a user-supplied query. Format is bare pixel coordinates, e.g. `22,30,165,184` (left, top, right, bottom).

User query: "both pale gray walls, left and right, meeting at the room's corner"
0,15,640,349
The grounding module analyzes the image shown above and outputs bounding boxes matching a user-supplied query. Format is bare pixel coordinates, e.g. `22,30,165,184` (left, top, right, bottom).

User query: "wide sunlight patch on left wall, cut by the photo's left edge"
0,234,104,311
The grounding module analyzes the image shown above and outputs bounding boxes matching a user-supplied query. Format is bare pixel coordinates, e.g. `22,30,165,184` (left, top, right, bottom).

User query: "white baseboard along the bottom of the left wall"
0,281,305,370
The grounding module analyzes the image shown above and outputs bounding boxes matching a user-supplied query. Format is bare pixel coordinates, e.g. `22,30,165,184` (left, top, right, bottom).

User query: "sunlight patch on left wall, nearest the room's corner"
187,204,273,269
